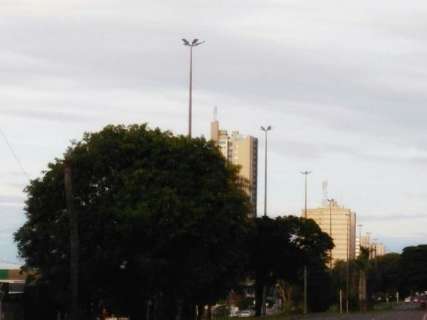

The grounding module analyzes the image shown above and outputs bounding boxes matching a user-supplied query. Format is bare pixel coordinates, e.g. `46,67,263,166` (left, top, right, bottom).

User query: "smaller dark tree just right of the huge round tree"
249,216,333,316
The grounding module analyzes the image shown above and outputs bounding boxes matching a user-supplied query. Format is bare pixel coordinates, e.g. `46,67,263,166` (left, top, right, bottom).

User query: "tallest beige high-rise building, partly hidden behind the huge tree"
211,120,258,217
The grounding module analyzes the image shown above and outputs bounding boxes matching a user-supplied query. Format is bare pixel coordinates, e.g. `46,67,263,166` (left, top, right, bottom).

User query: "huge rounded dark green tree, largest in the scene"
15,125,249,319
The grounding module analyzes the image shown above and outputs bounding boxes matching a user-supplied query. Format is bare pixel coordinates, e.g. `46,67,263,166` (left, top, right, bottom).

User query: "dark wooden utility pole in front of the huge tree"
64,160,79,320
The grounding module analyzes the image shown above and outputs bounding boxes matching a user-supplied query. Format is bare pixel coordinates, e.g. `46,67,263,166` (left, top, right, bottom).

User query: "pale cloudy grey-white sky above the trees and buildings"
0,0,427,262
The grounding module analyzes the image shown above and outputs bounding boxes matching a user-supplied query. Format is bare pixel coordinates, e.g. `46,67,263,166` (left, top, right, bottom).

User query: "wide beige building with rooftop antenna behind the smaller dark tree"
303,201,356,263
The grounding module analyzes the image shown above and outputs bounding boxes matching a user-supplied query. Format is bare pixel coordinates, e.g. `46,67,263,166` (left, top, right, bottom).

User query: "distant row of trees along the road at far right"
332,245,427,310
